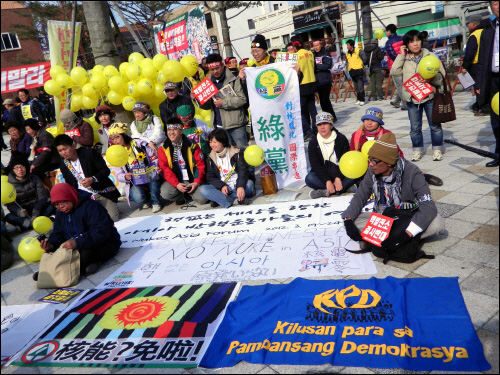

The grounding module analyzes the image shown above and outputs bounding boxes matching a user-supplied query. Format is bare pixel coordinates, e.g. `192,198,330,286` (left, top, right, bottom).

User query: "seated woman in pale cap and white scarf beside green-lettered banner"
306,112,355,199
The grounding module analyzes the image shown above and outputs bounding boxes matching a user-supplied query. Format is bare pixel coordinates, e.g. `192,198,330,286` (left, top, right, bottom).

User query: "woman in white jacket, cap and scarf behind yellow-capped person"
130,102,167,156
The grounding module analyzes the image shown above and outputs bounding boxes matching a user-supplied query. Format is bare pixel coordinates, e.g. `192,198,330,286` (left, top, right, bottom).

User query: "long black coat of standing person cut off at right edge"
474,19,498,108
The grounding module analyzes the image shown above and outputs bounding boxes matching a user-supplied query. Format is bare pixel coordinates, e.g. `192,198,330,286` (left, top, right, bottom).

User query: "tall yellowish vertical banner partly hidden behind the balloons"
47,21,82,135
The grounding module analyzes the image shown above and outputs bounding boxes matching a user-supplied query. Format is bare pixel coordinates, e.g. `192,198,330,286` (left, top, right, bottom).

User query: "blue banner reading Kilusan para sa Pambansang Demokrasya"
200,277,490,372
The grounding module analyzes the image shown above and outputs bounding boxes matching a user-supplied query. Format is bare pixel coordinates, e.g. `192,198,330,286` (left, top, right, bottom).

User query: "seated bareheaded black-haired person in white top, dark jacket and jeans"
200,129,254,208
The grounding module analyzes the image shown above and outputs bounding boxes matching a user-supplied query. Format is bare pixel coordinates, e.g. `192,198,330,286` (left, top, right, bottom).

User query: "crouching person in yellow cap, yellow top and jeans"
109,123,161,213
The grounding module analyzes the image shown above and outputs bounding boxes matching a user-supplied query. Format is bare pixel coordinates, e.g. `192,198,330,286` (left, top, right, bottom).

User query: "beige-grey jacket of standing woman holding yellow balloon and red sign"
391,48,446,104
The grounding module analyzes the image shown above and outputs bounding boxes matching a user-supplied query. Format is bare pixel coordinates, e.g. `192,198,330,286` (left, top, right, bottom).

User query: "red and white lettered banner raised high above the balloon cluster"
153,4,212,63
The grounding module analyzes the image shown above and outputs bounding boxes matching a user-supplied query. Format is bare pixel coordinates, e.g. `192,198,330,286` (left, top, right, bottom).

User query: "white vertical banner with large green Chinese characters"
245,61,307,189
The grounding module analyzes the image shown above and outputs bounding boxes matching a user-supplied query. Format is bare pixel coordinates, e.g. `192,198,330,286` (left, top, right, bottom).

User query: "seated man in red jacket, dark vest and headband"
158,117,208,205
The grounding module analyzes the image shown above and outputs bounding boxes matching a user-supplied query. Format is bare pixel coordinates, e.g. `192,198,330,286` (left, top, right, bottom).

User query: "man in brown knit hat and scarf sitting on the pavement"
342,133,444,260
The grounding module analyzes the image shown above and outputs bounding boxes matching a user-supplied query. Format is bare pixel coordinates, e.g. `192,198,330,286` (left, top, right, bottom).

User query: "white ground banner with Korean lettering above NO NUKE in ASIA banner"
115,196,371,248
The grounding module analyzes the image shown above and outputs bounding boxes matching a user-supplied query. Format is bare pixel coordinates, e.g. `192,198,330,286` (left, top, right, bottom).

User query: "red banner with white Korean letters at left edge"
2,62,50,94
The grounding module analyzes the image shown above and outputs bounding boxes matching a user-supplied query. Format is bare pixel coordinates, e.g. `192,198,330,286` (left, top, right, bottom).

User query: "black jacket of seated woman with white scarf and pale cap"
307,129,349,184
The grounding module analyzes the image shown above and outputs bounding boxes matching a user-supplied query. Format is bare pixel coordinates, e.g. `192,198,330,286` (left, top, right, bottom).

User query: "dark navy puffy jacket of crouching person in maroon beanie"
49,190,122,254
